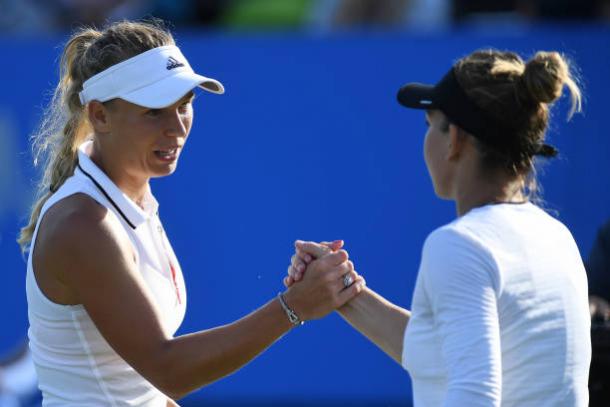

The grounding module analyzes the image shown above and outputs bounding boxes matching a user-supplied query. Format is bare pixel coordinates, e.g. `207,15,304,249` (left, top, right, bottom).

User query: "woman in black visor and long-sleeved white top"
285,50,591,407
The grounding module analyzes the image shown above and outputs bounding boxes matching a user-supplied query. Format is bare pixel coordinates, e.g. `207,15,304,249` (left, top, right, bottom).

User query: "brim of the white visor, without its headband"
119,72,225,109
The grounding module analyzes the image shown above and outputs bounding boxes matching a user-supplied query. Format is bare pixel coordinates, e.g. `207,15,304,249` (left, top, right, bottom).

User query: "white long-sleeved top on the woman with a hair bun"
402,203,591,407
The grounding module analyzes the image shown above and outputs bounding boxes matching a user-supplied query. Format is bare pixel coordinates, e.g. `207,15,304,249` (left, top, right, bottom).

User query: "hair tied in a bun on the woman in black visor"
454,49,582,176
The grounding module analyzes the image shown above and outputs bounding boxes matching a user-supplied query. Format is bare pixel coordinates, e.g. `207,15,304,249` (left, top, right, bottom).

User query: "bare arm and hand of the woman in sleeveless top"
35,197,361,397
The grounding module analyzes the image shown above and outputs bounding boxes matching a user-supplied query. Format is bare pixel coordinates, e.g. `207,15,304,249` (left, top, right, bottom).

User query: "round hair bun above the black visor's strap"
521,51,570,103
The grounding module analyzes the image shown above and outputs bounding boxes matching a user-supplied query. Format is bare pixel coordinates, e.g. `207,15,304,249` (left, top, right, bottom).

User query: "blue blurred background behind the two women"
0,0,610,406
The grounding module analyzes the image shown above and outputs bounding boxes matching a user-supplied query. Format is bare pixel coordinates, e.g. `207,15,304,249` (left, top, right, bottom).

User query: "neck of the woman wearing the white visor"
90,142,150,208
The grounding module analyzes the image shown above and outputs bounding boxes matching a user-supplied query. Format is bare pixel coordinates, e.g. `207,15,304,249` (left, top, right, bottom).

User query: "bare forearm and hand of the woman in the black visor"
285,242,411,364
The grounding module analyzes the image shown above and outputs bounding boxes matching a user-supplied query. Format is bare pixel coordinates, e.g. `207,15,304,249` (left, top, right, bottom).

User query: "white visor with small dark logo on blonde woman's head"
79,45,225,109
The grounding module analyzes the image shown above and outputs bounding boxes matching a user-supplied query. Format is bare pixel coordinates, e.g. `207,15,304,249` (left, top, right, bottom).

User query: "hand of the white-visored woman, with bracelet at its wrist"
284,246,365,321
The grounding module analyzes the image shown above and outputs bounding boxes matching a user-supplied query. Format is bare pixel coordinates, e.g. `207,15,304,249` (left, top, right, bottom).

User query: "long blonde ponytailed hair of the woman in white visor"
17,20,174,252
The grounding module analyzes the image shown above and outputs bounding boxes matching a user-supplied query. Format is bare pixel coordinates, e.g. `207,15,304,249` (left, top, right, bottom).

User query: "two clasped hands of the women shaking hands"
280,240,366,323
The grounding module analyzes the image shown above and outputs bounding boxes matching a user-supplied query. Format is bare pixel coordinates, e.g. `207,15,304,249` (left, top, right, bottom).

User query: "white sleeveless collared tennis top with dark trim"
26,141,186,407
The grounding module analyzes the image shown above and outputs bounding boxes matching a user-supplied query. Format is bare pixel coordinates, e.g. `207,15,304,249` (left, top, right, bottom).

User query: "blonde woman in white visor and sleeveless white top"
19,22,363,407
